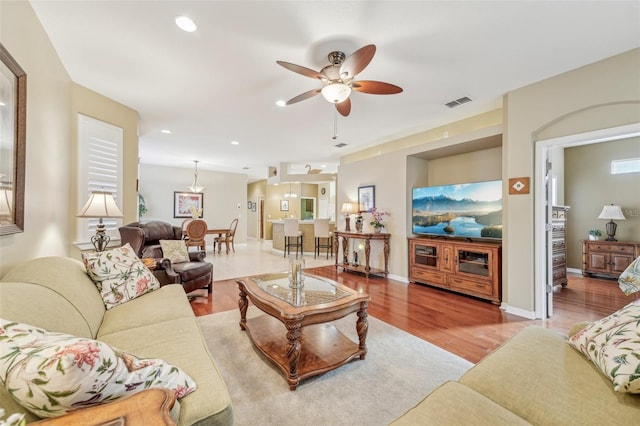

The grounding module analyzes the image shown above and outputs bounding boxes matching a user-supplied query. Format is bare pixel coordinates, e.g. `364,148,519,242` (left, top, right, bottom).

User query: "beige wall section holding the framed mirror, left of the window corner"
0,1,72,276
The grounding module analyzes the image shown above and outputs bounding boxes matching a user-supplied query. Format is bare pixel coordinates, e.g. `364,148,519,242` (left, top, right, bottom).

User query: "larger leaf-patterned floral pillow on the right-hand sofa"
569,300,640,393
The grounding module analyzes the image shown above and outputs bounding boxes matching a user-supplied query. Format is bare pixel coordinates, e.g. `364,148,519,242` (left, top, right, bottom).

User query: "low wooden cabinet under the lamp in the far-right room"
582,240,640,278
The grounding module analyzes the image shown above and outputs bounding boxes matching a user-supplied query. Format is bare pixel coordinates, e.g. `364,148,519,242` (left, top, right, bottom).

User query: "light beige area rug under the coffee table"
198,306,473,426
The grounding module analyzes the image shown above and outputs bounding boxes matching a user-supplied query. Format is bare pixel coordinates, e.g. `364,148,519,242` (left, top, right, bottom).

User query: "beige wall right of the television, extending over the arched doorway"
503,49,640,312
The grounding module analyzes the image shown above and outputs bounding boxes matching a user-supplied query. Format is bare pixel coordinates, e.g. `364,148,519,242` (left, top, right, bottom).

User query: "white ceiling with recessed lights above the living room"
31,0,640,180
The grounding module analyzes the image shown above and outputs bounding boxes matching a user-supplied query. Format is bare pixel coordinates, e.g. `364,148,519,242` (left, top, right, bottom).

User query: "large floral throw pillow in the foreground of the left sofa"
0,318,196,417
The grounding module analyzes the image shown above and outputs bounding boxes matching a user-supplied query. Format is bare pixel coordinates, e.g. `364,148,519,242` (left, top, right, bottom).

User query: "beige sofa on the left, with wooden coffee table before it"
0,257,233,425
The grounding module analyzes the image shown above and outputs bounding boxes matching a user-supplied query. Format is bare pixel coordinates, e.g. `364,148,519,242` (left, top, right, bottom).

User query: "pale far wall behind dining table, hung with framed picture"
139,164,247,245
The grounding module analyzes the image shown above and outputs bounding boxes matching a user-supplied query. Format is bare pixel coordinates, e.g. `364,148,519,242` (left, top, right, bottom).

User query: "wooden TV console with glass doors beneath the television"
408,237,502,305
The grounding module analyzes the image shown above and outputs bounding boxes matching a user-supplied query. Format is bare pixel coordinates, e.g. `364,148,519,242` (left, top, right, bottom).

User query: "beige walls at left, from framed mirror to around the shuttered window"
0,1,138,276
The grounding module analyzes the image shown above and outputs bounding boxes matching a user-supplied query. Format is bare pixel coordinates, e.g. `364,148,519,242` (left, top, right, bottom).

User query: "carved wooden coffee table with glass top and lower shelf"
236,273,369,390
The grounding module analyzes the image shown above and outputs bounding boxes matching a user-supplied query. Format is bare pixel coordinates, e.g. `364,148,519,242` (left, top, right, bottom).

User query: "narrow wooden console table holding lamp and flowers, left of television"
333,231,391,278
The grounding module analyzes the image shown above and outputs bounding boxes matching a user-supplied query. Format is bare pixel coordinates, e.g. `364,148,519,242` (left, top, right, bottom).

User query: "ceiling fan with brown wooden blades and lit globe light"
276,44,402,117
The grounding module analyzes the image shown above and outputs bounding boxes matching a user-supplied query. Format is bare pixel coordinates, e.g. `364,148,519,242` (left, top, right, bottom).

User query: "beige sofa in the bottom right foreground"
392,326,640,426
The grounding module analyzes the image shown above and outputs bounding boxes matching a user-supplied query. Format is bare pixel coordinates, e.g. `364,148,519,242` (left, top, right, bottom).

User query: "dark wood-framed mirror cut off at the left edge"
0,43,27,235
